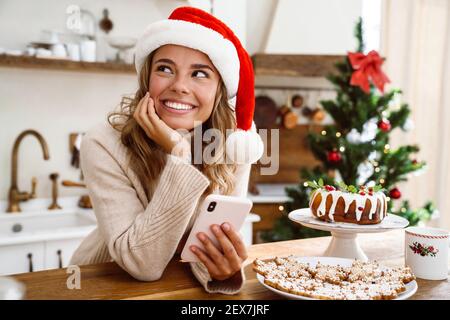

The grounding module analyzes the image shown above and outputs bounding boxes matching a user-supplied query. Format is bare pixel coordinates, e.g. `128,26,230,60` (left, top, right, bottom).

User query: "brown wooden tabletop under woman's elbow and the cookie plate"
13,230,450,300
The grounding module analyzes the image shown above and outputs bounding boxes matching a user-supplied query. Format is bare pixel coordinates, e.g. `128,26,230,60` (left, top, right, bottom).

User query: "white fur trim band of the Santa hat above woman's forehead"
135,19,240,98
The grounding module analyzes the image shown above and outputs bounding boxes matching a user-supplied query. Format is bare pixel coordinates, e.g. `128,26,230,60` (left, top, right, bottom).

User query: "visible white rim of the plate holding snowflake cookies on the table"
256,257,418,300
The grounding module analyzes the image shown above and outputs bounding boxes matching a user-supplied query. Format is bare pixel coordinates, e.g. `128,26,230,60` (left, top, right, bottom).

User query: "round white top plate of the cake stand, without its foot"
289,208,409,232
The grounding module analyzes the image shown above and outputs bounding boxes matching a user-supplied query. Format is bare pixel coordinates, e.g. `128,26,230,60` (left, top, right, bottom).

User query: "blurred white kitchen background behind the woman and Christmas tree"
0,0,450,275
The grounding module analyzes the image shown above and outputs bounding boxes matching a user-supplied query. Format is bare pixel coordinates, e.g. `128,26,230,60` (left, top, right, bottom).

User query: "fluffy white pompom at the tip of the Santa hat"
226,130,264,164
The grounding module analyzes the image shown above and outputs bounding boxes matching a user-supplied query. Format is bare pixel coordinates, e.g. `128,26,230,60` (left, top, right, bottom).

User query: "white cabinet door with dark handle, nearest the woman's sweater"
45,238,83,269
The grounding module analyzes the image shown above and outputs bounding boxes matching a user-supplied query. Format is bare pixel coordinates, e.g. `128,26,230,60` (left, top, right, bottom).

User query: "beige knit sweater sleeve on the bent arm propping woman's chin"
80,130,209,281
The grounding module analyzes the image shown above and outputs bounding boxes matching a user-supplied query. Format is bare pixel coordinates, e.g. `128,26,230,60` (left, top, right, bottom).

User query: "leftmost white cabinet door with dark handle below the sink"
0,242,45,275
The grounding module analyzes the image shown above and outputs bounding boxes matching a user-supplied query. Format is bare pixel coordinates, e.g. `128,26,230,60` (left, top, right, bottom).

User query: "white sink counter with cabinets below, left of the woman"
0,196,97,276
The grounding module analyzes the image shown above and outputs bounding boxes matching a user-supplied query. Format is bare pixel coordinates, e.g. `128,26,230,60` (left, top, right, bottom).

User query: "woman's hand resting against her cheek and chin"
133,92,191,160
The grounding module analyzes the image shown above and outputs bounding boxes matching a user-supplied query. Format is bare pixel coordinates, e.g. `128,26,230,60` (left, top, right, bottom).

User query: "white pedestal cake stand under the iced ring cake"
289,208,409,261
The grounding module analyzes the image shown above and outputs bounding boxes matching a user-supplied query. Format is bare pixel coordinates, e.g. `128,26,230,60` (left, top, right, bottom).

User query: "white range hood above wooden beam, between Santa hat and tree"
262,0,362,54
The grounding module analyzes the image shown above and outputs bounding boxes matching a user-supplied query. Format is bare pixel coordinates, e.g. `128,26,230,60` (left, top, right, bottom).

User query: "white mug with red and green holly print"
405,227,450,280
